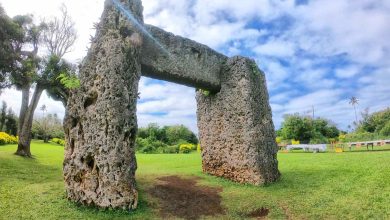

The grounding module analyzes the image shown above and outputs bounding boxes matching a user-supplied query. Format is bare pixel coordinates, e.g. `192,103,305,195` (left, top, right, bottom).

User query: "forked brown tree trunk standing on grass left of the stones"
15,85,43,157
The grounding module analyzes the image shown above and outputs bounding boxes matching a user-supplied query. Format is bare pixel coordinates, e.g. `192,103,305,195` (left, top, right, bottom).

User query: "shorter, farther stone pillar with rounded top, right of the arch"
196,57,280,185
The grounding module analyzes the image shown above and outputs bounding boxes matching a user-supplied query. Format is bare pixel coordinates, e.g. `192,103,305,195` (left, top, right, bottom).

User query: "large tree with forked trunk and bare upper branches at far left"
0,5,78,157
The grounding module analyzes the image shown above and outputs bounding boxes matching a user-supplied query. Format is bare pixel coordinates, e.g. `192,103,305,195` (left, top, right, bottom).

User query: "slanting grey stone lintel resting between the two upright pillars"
141,25,227,92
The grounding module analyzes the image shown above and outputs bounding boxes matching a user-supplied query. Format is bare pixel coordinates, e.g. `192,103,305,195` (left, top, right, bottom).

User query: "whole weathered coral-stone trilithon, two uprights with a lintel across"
63,0,280,209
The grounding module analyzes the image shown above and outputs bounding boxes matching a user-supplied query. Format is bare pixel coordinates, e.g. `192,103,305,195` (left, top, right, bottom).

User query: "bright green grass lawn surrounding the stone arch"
0,141,390,219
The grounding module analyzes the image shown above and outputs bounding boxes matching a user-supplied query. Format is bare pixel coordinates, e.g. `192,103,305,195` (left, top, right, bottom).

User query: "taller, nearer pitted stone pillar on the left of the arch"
63,0,143,209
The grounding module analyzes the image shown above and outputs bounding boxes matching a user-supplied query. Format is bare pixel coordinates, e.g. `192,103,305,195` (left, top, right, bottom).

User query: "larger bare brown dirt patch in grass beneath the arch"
149,176,225,219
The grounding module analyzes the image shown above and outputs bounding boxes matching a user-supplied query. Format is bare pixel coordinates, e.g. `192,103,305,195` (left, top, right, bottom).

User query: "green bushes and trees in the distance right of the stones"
276,108,390,144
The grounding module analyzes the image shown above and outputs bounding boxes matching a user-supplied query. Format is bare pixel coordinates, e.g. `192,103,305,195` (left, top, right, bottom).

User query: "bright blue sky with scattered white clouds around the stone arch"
0,0,390,130
